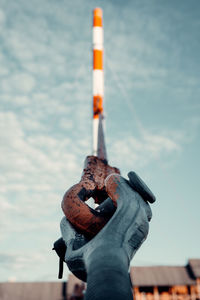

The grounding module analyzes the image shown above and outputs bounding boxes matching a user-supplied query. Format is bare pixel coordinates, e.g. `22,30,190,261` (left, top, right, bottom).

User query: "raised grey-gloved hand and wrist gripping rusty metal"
61,172,155,300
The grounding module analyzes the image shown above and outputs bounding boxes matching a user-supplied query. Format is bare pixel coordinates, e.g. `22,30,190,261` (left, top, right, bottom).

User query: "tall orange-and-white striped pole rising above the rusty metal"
93,8,104,156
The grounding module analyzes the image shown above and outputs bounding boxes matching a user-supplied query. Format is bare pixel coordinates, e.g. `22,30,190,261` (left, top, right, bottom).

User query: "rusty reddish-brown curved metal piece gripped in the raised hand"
61,156,120,237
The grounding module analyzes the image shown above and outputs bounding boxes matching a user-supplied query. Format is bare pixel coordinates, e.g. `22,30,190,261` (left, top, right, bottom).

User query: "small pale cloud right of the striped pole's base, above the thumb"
110,131,184,171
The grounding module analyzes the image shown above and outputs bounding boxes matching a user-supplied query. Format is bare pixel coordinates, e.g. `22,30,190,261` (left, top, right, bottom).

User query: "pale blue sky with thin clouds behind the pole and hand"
0,0,200,281
